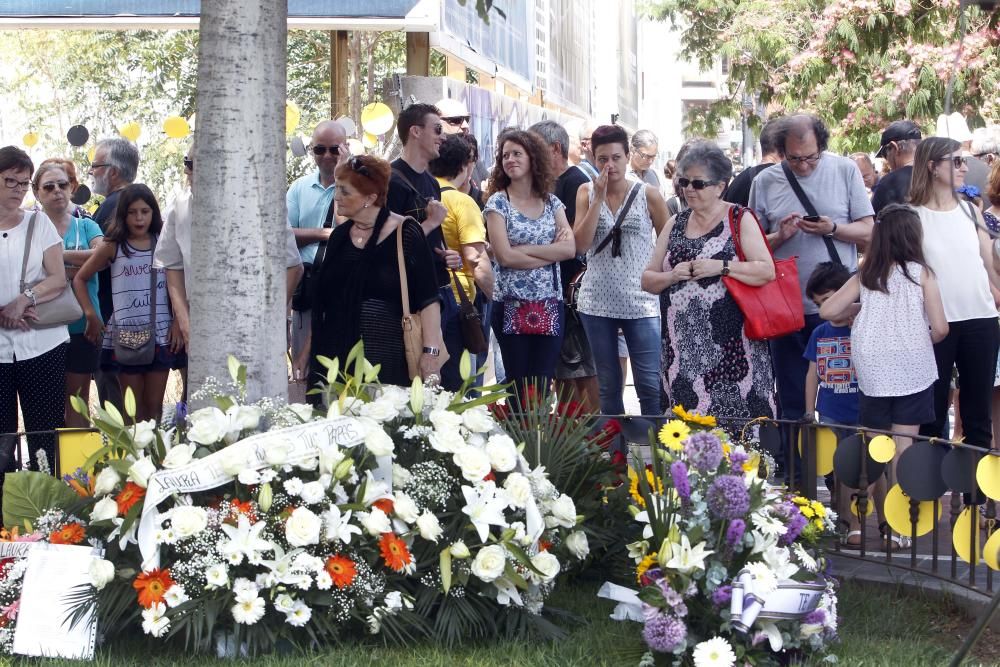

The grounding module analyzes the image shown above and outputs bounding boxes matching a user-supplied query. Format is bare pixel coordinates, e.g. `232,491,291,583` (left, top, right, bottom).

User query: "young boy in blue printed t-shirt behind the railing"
802,262,899,549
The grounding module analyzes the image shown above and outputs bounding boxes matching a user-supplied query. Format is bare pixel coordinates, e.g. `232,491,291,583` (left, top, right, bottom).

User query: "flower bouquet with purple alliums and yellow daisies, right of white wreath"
600,408,837,667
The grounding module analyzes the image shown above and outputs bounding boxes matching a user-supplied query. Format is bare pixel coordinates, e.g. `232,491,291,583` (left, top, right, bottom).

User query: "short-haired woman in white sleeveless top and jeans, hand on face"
573,125,670,415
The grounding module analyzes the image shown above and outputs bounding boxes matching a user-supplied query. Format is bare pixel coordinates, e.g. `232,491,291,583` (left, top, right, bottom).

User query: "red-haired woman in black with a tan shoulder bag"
296,156,443,386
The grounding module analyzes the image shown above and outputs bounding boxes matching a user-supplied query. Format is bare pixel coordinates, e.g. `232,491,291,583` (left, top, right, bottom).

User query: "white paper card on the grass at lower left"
13,544,98,660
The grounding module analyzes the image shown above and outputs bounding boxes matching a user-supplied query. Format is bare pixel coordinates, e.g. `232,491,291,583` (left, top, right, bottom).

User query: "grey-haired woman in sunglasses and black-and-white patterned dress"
642,141,774,418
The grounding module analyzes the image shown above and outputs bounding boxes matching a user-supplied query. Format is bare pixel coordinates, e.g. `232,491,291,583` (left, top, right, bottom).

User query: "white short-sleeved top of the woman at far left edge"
0,211,69,364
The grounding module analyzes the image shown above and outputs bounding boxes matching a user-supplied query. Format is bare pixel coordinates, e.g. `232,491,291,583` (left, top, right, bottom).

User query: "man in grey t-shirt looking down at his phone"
750,114,874,470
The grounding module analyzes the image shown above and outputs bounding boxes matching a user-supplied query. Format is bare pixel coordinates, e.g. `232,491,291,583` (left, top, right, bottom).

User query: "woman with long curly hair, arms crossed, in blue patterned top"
484,130,576,404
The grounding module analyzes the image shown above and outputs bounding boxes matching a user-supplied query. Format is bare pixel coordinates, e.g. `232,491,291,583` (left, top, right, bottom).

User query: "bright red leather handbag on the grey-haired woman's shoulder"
722,206,805,340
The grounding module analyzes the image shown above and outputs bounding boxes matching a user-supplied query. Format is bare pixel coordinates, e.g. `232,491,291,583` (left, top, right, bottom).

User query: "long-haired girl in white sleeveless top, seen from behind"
819,204,948,473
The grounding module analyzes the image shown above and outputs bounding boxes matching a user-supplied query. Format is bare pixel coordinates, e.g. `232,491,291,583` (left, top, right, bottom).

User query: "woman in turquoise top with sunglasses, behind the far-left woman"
31,158,104,428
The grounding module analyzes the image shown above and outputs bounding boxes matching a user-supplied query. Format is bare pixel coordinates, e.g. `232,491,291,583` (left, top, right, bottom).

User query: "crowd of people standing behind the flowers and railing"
0,99,1000,506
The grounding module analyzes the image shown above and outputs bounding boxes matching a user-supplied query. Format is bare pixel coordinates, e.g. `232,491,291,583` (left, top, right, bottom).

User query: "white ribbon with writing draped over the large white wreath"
137,417,364,570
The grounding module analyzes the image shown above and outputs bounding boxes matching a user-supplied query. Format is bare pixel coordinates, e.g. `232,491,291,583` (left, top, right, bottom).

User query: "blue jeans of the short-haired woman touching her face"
580,313,661,415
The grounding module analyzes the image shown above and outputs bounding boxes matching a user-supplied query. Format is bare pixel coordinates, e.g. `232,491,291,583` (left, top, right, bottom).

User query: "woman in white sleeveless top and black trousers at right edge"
910,137,1000,447
